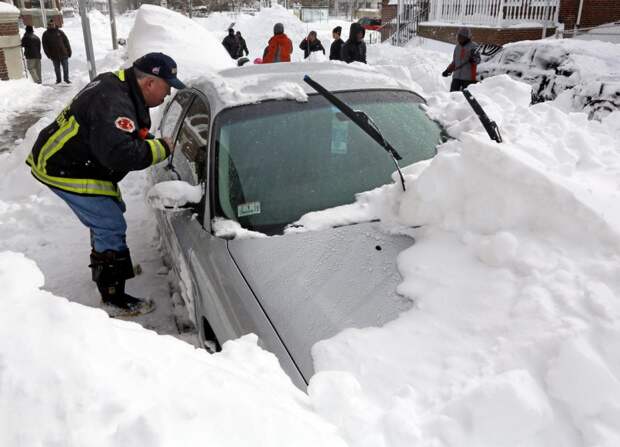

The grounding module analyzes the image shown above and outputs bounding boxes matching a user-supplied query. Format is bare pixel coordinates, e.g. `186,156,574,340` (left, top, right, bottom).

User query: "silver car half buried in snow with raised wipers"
154,63,443,388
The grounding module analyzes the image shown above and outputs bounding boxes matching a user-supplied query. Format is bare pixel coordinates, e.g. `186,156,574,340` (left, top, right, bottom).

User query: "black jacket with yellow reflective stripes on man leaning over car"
26,68,170,197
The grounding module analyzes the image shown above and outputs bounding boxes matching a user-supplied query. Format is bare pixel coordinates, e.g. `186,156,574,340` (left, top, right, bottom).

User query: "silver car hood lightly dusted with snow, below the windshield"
228,222,414,381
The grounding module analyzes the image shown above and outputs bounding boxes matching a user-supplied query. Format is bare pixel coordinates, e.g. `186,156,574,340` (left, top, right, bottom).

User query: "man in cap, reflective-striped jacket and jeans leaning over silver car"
26,53,185,315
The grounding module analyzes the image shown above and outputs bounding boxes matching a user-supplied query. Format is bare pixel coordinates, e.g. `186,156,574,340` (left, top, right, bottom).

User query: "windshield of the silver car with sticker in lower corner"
215,90,442,234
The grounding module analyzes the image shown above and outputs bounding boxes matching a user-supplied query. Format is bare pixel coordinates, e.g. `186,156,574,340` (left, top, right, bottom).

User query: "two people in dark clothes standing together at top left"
22,20,71,84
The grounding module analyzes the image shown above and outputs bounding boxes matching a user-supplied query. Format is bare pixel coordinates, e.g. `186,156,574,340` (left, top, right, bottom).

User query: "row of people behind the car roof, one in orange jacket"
222,23,366,64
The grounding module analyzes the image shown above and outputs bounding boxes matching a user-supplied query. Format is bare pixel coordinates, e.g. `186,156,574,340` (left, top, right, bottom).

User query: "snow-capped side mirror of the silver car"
146,180,203,211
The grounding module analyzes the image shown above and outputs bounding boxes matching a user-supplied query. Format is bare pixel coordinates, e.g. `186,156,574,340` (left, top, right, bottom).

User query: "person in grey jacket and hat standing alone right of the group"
441,27,480,92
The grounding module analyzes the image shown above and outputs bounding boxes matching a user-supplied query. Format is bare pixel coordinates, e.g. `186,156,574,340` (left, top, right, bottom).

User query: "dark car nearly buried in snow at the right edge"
478,39,620,119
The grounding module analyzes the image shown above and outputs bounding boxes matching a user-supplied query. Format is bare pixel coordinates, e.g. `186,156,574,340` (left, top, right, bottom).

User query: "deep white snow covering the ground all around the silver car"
0,7,620,447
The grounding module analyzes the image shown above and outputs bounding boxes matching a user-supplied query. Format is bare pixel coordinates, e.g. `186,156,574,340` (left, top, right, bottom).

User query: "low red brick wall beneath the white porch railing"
418,25,555,45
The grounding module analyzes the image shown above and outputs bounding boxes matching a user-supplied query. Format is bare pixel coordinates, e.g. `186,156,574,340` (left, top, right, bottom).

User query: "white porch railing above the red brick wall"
428,0,560,27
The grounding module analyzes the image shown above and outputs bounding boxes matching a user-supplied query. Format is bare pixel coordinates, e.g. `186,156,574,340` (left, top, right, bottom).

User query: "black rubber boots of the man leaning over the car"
90,250,155,316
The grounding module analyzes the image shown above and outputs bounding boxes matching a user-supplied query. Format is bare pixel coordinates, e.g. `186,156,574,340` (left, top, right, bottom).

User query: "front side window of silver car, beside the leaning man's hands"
172,97,210,185
